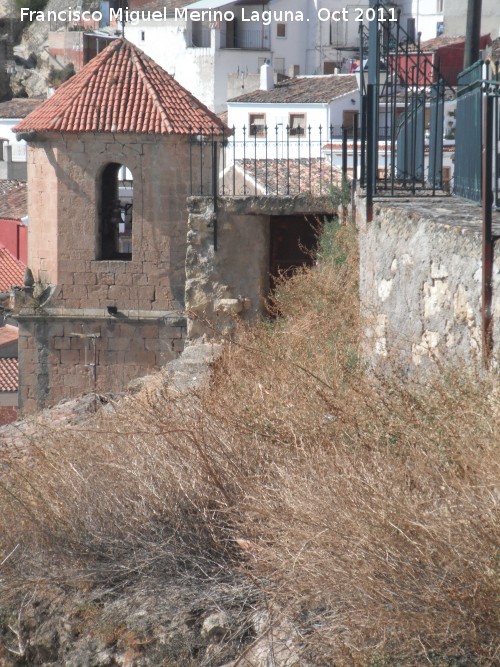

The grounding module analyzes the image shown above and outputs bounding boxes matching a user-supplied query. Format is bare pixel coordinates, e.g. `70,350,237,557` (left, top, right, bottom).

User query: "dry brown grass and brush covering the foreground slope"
0,225,500,667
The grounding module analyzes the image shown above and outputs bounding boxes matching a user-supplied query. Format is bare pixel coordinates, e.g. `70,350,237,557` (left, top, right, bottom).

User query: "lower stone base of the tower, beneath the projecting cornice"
19,308,186,413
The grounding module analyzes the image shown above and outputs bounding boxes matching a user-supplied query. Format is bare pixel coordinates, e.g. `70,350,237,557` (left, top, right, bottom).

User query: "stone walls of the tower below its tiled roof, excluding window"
16,132,210,412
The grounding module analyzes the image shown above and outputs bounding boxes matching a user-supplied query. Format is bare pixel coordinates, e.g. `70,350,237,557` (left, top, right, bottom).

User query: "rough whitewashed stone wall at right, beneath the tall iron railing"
358,197,500,373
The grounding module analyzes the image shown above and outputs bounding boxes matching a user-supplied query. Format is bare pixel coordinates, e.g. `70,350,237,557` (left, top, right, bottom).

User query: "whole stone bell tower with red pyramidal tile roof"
15,39,224,412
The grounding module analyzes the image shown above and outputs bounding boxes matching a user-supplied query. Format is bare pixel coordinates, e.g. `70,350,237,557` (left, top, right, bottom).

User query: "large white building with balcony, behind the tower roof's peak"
124,0,369,112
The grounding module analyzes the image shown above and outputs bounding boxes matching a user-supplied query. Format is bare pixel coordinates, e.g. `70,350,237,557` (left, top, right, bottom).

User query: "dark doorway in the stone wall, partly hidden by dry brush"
269,215,320,290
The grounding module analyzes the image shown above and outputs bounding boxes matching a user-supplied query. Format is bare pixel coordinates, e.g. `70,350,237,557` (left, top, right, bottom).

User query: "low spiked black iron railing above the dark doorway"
189,124,352,197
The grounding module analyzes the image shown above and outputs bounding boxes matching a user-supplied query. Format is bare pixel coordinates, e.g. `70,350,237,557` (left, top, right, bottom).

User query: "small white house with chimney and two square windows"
226,65,359,163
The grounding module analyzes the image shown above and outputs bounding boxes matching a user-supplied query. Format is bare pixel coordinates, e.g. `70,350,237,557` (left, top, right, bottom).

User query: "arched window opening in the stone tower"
98,162,134,260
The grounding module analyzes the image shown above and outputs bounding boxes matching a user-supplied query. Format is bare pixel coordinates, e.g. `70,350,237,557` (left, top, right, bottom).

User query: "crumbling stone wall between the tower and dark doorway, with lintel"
185,195,336,338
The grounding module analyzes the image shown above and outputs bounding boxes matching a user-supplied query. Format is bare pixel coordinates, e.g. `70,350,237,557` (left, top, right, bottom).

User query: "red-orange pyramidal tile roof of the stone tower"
14,39,224,135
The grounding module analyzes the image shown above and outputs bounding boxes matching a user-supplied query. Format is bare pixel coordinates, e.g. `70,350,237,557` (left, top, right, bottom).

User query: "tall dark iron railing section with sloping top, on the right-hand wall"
360,0,453,219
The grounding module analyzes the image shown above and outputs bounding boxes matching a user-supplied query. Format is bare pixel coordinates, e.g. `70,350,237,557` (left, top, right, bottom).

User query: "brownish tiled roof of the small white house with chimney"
228,74,358,104
